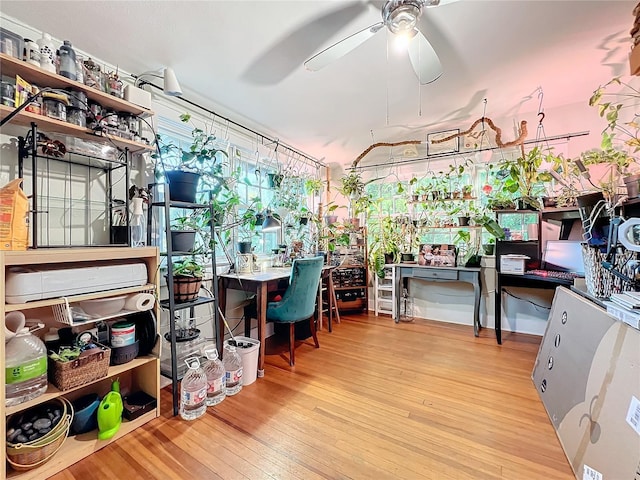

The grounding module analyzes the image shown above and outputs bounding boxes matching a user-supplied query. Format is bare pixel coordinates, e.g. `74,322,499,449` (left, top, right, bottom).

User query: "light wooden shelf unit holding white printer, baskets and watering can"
0,247,160,480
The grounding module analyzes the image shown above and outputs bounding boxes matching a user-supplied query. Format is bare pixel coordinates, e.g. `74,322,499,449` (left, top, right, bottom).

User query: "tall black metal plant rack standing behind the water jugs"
147,183,222,415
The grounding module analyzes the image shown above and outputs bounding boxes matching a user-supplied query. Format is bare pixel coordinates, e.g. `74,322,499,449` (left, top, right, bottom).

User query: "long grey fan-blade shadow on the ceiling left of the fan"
242,2,368,85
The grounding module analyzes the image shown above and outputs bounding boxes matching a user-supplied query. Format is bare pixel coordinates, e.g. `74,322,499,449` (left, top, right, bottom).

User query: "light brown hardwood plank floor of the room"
52,315,574,480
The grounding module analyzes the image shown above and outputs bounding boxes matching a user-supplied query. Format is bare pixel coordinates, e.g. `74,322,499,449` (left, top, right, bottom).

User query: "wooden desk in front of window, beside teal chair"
218,267,291,377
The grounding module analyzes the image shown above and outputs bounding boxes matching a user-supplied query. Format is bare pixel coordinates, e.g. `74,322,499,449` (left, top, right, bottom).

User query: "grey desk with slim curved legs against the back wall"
393,263,482,337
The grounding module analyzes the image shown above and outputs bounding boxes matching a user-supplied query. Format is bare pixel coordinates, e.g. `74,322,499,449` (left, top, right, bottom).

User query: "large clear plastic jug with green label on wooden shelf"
5,328,48,407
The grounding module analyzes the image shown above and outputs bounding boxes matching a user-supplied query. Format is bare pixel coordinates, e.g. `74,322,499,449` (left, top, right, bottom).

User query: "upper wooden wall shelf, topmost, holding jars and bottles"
0,53,154,117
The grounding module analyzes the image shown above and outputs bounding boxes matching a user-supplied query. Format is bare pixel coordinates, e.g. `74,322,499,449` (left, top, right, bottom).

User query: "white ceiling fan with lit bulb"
304,0,456,85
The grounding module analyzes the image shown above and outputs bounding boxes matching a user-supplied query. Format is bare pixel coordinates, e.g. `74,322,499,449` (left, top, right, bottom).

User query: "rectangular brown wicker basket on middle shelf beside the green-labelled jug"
49,344,111,391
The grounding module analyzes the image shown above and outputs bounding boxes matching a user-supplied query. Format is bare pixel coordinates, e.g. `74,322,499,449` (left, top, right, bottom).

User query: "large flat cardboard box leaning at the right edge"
532,287,640,480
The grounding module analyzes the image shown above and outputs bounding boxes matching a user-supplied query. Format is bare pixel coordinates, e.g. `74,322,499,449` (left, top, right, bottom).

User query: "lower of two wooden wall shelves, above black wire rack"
0,105,155,153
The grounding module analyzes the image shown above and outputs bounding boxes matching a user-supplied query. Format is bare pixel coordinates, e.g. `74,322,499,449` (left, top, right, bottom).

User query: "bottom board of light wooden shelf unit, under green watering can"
7,408,159,480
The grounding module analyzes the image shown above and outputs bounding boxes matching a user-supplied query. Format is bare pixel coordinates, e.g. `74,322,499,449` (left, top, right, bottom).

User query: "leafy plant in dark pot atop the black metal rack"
151,113,227,203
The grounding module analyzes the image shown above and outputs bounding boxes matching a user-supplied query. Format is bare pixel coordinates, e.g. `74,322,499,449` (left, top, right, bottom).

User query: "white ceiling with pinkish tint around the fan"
0,0,636,171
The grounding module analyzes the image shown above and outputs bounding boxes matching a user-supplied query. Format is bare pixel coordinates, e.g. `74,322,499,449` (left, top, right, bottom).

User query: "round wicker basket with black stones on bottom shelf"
7,397,73,471
